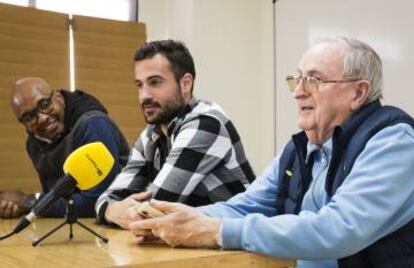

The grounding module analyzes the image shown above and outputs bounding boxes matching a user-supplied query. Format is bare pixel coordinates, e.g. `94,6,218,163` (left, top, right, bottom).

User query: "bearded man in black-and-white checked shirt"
96,40,255,228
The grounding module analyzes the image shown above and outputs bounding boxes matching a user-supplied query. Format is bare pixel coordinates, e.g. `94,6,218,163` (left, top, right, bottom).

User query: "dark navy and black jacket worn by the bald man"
26,90,129,217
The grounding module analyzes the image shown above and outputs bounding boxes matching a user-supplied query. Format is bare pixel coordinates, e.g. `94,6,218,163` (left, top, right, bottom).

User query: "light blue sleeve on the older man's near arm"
207,124,414,260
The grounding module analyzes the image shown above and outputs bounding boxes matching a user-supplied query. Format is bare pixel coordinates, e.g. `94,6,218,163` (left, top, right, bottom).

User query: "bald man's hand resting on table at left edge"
0,190,26,218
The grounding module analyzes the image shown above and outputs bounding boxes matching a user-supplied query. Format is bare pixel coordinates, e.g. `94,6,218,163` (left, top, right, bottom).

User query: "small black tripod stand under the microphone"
32,195,109,247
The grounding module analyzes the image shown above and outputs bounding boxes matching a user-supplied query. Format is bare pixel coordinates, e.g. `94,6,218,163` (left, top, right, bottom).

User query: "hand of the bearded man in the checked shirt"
105,192,151,229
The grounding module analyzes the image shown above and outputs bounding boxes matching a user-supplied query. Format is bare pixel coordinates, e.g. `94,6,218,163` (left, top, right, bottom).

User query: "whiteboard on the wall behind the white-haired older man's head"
274,0,414,150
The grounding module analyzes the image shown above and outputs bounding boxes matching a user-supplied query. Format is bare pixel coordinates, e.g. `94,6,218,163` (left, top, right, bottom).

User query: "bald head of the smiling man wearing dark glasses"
10,77,64,140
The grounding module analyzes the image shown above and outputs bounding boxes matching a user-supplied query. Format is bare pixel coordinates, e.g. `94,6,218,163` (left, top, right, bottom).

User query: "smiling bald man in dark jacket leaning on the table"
0,77,129,218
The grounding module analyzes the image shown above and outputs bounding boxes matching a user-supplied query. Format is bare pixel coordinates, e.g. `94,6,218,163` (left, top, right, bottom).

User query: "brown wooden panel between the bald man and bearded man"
74,16,146,144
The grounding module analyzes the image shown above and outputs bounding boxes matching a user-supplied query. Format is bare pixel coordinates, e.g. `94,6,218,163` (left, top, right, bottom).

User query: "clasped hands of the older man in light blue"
129,200,221,248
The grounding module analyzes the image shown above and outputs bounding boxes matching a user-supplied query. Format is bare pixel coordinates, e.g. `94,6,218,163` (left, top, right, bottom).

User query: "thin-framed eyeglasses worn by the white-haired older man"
286,75,361,94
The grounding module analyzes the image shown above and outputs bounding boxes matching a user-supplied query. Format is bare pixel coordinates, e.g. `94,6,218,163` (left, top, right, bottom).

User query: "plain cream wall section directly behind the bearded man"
139,0,275,173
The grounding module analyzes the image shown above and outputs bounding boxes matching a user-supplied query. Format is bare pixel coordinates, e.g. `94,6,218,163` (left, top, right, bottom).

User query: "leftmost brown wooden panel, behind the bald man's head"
0,4,69,192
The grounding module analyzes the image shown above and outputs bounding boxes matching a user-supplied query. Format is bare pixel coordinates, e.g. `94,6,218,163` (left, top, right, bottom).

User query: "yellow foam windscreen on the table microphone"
63,142,115,190
